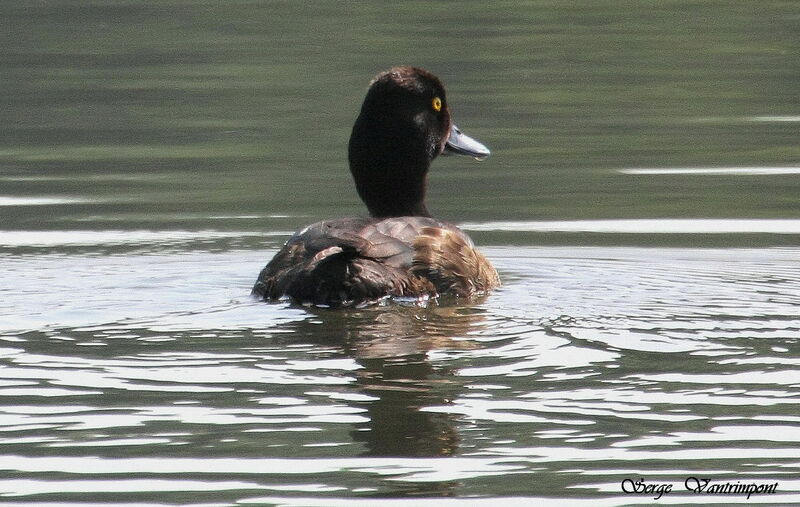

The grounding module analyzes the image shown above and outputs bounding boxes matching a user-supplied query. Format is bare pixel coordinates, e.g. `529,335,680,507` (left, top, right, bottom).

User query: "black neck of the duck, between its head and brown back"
349,122,431,217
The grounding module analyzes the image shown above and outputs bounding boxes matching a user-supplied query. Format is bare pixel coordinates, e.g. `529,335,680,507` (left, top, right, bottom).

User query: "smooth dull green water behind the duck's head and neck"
0,1,800,229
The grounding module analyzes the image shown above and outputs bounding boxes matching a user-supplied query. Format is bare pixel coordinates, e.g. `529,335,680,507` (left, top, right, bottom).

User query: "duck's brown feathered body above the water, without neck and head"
253,217,500,306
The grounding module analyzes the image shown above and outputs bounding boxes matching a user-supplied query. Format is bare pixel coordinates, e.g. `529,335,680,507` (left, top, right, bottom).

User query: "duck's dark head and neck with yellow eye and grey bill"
349,67,489,217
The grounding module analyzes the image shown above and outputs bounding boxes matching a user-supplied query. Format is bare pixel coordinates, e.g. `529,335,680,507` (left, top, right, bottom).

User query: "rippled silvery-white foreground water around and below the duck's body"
0,247,800,505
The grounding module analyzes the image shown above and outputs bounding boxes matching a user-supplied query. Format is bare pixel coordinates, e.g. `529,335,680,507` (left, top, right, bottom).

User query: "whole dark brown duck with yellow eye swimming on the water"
252,66,500,307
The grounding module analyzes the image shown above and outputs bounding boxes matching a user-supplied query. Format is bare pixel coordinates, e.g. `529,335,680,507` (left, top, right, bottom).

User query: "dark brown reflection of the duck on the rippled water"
288,305,484,456
